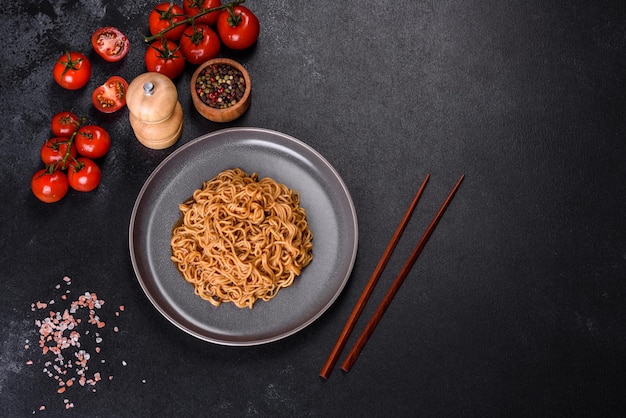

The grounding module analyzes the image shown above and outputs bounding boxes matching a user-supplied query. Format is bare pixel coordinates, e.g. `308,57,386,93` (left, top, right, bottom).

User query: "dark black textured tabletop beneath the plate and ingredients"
0,0,626,417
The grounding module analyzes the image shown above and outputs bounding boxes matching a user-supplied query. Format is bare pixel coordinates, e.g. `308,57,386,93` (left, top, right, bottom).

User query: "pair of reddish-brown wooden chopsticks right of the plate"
320,174,465,379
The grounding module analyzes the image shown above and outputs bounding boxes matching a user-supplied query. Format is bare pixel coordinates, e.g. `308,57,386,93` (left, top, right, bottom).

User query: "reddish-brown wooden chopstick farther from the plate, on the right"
341,175,465,372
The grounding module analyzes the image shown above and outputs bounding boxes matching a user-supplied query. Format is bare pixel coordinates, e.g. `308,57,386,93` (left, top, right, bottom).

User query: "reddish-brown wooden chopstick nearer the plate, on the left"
320,174,430,379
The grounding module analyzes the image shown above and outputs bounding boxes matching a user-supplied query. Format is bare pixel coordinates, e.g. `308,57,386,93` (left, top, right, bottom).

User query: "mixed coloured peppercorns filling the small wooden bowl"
196,64,246,109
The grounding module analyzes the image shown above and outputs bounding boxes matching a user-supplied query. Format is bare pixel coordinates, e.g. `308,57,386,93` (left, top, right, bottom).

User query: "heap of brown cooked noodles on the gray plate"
171,168,313,308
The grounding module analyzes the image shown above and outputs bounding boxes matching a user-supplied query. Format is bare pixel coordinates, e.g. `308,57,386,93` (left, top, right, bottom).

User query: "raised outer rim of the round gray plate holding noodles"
128,127,359,346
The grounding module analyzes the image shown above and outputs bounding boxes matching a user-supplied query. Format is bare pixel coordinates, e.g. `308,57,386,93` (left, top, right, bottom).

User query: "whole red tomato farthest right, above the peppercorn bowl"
217,6,260,49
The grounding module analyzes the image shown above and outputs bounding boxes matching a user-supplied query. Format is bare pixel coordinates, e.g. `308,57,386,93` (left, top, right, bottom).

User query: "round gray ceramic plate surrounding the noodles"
129,128,358,346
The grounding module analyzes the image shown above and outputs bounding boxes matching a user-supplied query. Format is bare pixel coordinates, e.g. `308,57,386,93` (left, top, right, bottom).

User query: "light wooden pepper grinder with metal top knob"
126,72,183,149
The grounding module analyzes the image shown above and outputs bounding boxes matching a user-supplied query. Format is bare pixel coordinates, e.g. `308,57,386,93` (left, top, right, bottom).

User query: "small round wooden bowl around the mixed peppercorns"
190,58,252,122
